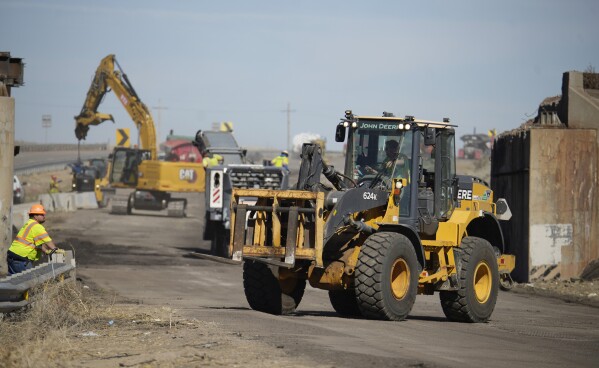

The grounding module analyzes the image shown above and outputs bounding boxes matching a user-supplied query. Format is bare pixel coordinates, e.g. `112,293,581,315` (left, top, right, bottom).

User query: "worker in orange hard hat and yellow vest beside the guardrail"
6,204,64,275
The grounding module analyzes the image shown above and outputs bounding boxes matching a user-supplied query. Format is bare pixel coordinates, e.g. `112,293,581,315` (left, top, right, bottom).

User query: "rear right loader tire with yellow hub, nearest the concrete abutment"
439,236,499,323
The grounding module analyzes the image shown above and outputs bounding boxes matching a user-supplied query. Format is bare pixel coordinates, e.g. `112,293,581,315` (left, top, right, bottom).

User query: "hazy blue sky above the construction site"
0,0,599,148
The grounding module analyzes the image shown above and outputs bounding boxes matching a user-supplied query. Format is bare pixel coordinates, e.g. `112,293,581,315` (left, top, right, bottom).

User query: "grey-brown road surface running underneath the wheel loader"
47,187,599,367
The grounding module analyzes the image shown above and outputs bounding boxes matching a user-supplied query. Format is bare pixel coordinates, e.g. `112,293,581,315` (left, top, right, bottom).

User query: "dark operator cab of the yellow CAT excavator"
110,147,151,187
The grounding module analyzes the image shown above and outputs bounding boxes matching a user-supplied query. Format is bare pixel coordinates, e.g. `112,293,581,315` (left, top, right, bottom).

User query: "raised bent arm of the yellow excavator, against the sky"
75,54,157,160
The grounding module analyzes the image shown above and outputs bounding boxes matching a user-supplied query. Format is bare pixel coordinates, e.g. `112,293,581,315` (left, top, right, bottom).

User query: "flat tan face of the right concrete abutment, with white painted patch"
528,128,599,279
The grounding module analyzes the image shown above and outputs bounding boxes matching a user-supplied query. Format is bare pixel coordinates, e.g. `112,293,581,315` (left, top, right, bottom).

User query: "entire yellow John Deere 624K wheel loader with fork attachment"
229,110,515,322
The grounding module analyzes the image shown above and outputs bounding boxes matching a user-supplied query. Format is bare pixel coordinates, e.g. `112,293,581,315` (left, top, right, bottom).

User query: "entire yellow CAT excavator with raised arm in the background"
75,54,205,217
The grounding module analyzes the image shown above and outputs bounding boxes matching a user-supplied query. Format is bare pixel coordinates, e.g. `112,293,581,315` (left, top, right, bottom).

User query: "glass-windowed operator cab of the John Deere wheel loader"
335,112,456,237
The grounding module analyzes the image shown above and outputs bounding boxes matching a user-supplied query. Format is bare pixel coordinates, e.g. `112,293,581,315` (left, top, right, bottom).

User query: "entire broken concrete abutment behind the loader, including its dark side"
491,72,599,282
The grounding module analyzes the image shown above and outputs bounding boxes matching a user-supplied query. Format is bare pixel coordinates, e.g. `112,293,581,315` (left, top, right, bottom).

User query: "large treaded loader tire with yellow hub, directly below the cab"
355,232,420,321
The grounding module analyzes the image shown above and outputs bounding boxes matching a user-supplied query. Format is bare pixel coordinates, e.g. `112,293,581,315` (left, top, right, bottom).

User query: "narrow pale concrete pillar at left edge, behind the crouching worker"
0,97,15,275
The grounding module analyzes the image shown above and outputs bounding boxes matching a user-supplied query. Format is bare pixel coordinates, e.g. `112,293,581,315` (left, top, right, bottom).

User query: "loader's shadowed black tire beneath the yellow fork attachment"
243,261,306,315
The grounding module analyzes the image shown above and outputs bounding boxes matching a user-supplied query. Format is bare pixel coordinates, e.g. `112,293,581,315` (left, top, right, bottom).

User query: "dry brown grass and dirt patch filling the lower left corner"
0,283,330,368
